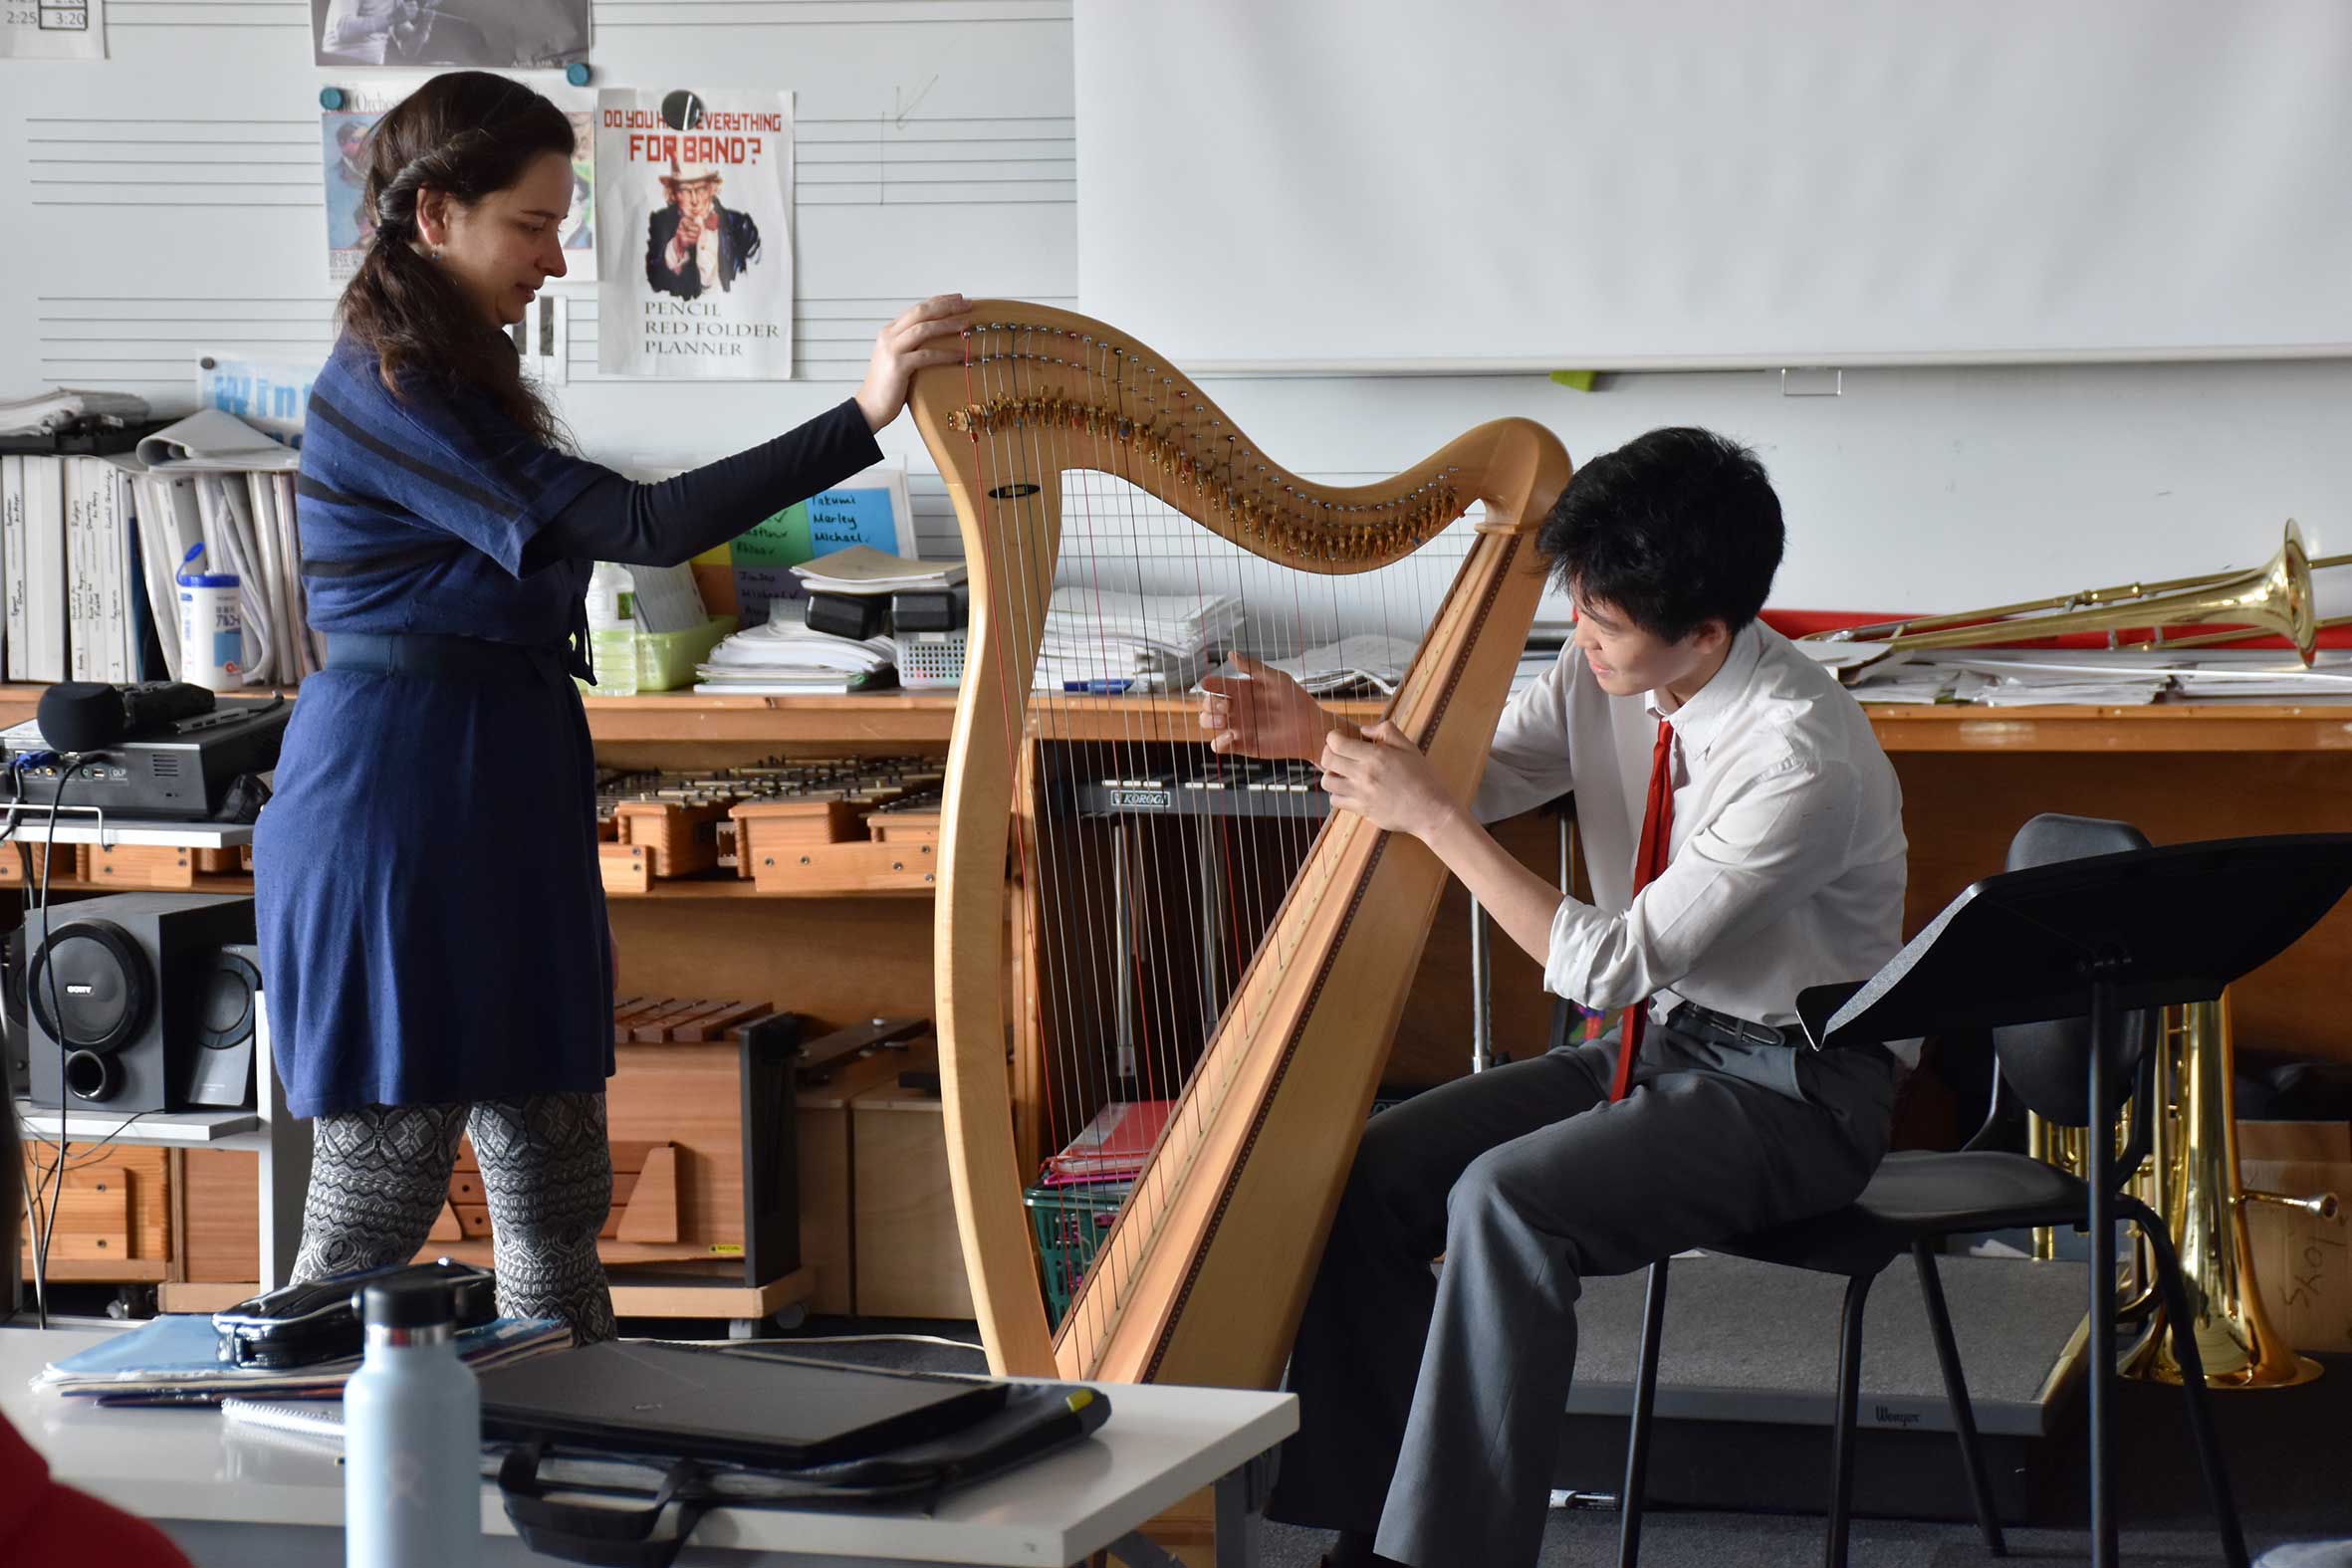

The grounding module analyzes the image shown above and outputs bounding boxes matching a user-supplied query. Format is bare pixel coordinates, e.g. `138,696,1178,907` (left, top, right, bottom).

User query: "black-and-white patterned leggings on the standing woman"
294,1093,613,1345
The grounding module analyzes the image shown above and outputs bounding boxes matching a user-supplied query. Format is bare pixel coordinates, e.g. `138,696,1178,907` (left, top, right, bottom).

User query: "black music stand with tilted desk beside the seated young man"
1797,832,2352,1568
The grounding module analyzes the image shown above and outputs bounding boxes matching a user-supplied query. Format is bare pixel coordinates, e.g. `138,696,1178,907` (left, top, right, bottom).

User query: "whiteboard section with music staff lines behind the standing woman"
0,0,1077,491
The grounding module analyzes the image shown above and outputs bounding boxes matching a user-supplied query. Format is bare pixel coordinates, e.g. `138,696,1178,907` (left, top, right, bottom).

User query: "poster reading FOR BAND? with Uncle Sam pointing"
595,87,793,381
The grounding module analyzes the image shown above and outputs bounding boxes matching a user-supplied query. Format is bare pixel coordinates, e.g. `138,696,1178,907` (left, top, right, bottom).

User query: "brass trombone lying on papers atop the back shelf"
1806,520,2352,665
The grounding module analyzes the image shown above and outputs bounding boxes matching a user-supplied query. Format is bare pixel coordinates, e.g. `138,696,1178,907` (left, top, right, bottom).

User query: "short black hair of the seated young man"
1535,428,1782,642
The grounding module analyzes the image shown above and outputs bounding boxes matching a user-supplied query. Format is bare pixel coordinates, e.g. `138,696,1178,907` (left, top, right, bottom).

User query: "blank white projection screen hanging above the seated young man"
1074,0,2352,369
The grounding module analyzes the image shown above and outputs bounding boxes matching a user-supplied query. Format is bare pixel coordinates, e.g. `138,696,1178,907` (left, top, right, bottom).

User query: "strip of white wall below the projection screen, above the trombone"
1176,359,2352,613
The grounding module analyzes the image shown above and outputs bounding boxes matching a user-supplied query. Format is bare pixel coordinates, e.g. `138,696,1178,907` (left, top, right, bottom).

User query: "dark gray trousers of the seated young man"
1268,1022,1896,1568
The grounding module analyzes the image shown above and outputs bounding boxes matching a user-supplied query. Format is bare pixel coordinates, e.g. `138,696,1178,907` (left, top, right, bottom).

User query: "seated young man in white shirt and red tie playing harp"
1200,430,1905,1568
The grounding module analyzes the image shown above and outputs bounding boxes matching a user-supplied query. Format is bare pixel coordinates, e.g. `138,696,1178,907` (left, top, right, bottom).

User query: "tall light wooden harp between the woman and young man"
912,301,1568,1387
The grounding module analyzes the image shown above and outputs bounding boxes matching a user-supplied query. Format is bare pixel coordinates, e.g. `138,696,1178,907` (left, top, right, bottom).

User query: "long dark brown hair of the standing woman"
337,71,574,444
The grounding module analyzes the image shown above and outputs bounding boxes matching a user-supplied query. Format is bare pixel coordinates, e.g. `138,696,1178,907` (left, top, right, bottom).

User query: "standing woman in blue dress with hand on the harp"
254,71,964,1342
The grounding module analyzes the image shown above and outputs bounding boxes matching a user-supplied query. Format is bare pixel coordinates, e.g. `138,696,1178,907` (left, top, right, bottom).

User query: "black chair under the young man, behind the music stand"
1618,815,2246,1568
